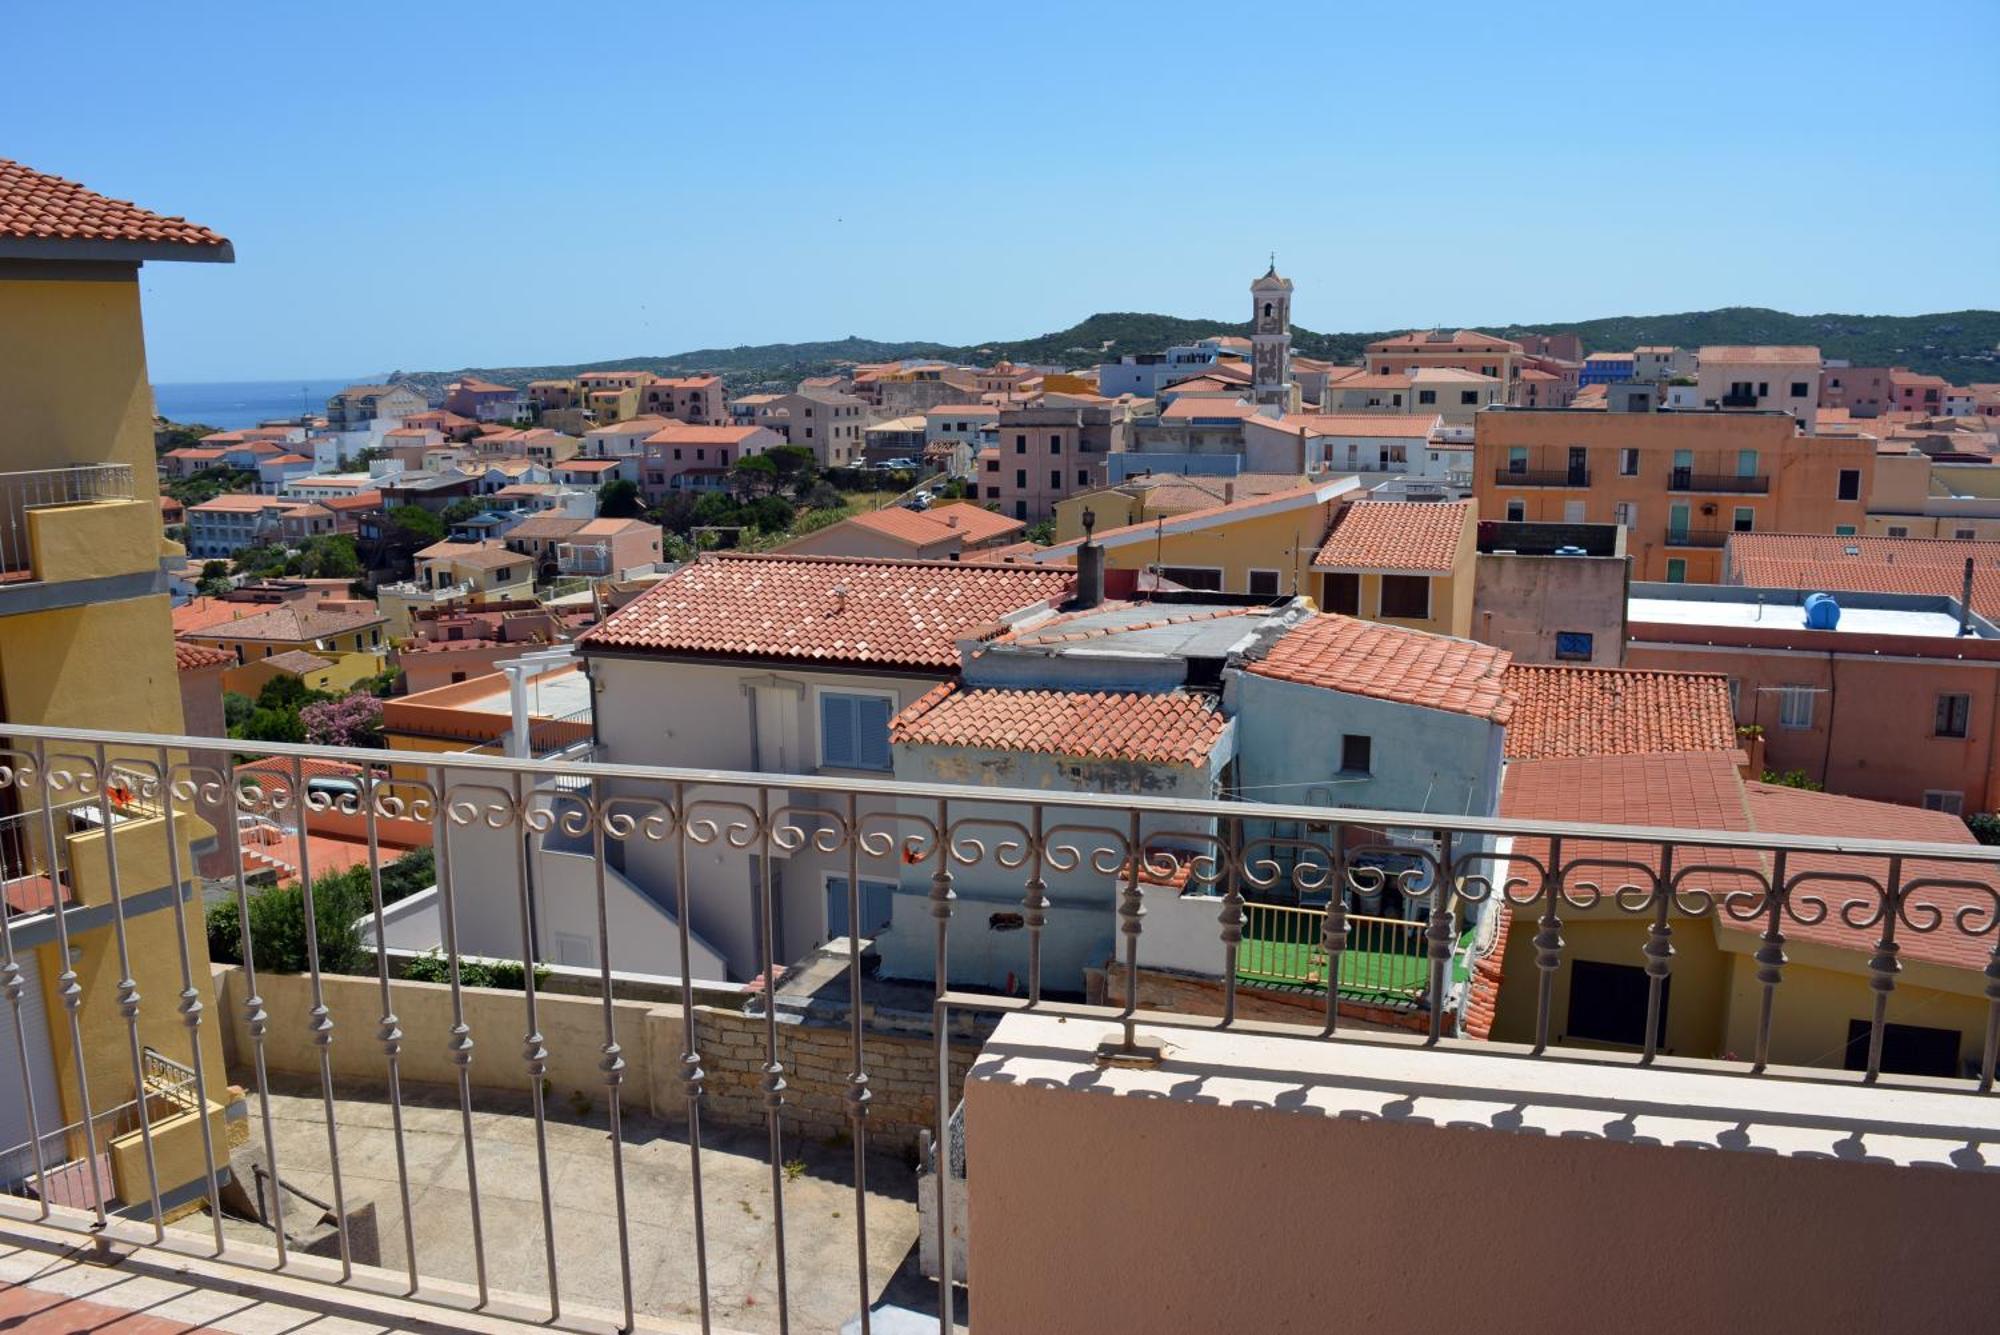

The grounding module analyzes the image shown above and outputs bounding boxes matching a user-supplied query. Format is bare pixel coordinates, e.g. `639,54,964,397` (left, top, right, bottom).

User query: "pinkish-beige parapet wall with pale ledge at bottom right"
952,1015,2000,1335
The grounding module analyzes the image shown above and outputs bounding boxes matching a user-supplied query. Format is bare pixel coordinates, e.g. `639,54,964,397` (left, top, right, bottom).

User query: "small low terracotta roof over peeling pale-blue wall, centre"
888,681,1228,765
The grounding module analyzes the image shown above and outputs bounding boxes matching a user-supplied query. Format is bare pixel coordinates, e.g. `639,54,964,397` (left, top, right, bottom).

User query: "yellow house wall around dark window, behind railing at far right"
1726,933,1986,1069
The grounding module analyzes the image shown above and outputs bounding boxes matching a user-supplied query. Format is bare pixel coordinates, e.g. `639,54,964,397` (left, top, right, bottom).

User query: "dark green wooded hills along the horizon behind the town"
388,306,2000,402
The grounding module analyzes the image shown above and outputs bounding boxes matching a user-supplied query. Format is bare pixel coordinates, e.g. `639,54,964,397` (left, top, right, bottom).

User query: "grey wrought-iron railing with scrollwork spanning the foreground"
0,725,2000,1331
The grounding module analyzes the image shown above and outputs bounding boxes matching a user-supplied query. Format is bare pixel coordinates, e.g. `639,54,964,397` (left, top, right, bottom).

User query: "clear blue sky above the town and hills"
0,0,2000,382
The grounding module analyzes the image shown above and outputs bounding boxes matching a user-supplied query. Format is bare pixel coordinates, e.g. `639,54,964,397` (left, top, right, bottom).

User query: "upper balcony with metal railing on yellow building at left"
0,464,145,586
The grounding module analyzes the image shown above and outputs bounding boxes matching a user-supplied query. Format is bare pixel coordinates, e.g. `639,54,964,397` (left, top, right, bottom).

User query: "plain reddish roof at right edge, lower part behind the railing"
1744,783,2000,969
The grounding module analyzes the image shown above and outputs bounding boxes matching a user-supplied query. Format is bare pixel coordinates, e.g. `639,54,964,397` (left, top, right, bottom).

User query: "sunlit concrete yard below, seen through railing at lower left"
174,1077,964,1331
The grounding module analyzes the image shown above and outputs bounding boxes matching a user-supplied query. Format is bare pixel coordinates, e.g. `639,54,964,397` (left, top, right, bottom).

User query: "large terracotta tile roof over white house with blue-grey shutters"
578,556,1070,671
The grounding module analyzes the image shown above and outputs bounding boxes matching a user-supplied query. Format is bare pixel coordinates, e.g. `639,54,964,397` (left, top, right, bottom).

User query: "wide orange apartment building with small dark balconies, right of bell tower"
1472,408,1876,584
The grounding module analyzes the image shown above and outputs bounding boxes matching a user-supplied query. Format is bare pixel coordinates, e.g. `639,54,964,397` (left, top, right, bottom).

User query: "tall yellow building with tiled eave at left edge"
0,160,234,1219
